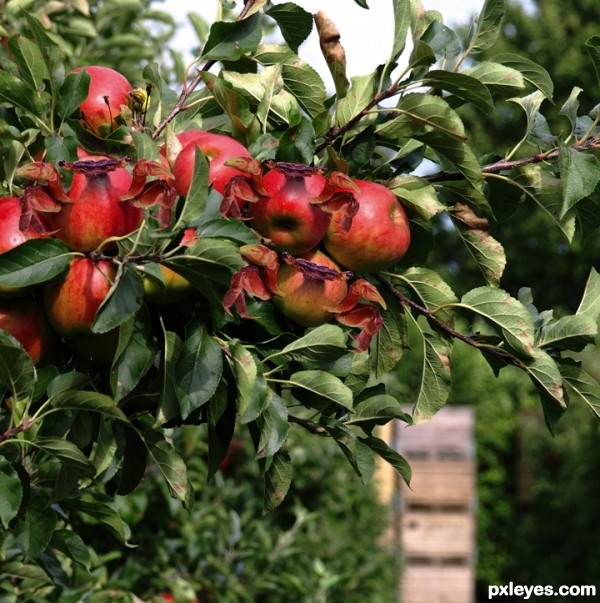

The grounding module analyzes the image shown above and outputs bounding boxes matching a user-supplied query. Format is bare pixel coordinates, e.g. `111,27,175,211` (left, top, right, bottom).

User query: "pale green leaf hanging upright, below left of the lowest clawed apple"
228,341,267,424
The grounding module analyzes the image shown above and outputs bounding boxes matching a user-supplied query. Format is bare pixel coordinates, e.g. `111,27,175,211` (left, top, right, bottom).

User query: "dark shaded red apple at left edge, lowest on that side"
0,298,55,364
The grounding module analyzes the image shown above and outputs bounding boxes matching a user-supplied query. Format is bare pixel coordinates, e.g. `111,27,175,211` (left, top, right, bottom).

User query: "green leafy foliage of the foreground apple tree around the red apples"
0,0,600,600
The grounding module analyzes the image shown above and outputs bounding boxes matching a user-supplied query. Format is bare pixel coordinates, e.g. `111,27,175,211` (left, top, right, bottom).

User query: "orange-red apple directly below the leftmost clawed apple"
44,257,118,361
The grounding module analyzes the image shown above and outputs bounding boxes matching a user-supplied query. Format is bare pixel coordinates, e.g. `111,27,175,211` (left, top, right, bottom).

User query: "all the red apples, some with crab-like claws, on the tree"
0,66,410,362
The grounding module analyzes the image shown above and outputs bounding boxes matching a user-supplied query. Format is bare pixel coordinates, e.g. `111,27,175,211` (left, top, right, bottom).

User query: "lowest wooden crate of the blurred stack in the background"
400,564,474,603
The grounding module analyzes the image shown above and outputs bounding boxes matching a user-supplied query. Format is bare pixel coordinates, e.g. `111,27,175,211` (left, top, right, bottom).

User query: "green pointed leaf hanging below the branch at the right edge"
558,143,600,218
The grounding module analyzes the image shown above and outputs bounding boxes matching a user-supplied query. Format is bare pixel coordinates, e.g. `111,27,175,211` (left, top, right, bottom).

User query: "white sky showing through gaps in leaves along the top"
161,0,484,76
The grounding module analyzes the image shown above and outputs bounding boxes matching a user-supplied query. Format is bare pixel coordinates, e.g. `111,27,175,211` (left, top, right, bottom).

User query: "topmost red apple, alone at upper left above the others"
71,65,132,137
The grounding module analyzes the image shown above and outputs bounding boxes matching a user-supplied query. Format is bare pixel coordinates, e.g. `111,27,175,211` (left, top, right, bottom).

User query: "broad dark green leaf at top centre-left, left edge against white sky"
202,15,262,61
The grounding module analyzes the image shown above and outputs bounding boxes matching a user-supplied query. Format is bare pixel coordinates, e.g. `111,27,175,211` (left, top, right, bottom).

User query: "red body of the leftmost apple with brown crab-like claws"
48,156,143,253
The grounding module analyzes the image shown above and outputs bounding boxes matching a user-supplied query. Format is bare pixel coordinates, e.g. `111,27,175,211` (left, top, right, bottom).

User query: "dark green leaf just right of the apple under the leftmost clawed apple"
92,266,144,333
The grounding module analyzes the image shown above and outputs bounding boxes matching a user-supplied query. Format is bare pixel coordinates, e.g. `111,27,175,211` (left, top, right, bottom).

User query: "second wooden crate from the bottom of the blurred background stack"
401,511,475,564
